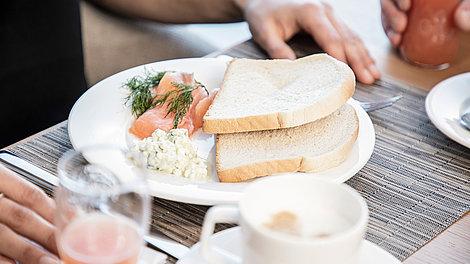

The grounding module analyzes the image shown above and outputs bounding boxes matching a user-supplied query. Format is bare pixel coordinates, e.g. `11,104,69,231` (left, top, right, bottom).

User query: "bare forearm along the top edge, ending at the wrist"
92,0,242,23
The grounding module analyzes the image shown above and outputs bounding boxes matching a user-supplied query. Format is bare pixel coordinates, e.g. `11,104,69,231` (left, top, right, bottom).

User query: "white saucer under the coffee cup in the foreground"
177,227,401,264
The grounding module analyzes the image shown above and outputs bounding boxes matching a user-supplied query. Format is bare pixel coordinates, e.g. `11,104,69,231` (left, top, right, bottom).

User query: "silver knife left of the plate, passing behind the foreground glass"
0,151,189,259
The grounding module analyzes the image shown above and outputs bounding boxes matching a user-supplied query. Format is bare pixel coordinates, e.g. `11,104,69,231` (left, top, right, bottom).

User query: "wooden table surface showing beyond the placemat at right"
320,0,470,264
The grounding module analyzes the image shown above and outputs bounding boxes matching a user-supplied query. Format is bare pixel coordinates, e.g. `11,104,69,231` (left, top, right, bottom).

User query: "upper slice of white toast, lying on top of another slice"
203,54,355,134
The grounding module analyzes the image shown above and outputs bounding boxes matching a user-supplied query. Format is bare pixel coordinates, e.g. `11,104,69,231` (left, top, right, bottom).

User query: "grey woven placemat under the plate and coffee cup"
4,77,470,262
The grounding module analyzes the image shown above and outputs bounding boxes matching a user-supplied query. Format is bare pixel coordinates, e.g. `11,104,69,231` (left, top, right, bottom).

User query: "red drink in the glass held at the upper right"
400,0,460,68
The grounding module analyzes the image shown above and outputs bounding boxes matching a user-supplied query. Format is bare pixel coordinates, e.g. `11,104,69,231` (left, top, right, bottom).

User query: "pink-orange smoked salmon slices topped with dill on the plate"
129,72,215,139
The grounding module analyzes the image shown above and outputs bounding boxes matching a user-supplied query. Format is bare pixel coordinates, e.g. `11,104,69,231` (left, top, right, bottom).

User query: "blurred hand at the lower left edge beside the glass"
0,165,59,264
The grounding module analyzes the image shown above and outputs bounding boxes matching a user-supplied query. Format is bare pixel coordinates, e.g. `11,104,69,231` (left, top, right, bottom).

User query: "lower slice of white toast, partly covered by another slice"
216,104,359,182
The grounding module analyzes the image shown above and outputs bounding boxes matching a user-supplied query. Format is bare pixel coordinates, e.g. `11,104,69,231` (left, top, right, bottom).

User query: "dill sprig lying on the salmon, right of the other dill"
154,82,199,128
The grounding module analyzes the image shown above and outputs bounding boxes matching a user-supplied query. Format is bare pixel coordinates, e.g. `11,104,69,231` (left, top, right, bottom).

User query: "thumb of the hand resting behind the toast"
252,22,296,60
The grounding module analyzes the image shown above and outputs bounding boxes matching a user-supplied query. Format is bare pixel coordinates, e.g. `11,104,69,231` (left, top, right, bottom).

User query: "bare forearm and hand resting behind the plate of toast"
94,0,380,83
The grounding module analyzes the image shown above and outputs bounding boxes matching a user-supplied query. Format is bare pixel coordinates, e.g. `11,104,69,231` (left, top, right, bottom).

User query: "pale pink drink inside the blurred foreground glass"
59,213,143,264
